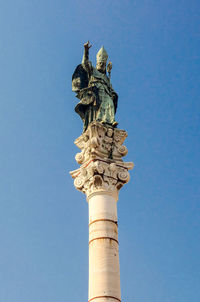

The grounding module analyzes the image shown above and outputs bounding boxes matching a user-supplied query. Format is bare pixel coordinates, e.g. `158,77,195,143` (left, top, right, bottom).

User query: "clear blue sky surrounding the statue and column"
0,0,200,302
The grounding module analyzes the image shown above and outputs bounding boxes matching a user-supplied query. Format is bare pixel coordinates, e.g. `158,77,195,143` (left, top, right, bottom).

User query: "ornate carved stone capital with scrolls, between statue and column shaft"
70,122,134,200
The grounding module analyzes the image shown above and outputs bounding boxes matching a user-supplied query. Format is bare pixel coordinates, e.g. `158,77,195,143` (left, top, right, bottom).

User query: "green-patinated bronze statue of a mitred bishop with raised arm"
72,41,118,131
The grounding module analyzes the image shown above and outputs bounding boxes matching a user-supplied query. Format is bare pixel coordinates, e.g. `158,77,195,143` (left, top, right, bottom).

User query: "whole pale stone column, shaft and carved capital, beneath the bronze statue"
70,122,133,302
